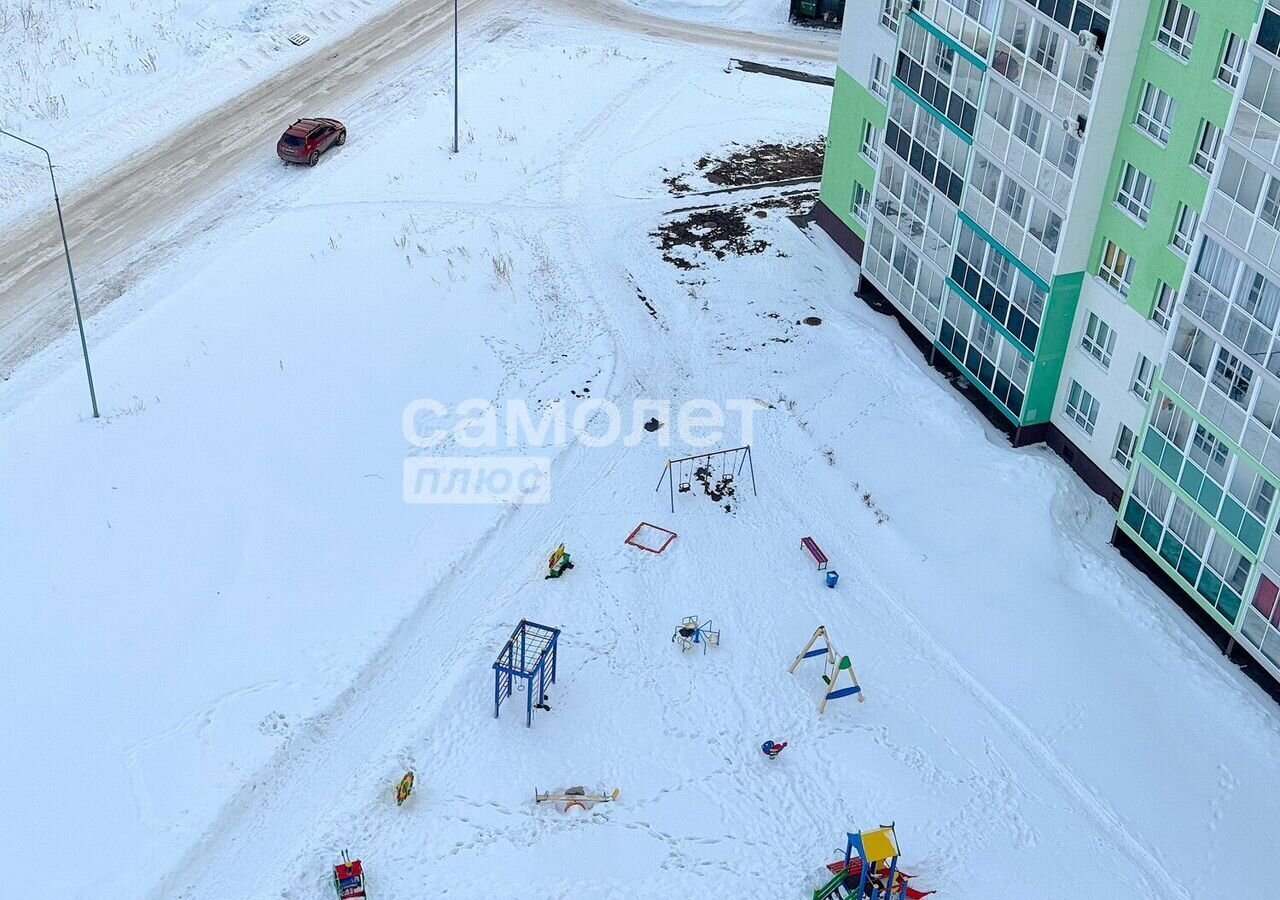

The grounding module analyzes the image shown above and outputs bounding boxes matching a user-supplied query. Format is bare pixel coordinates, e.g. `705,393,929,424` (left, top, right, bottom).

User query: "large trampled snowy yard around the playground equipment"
0,1,1280,900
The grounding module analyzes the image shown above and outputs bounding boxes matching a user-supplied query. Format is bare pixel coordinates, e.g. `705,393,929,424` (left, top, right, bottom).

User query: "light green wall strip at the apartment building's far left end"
819,67,888,241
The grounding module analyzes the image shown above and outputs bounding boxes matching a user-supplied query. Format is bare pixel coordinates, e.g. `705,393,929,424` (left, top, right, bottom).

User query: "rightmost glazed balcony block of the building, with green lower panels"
1119,0,1280,677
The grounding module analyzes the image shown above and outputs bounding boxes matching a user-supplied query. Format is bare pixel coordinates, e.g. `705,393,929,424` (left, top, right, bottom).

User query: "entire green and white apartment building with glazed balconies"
817,0,1280,679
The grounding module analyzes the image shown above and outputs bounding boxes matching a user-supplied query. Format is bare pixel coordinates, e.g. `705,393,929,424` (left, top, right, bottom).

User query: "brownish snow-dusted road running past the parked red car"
0,0,836,378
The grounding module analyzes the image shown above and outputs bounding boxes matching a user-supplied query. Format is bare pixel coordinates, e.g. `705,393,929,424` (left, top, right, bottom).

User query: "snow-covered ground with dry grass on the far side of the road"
0,0,396,223
